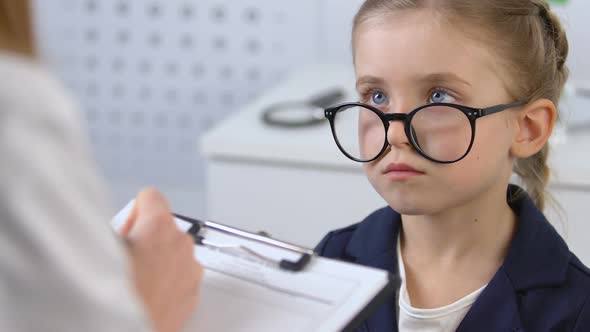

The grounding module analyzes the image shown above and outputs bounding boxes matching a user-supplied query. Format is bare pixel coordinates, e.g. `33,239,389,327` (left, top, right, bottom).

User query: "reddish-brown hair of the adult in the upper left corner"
0,0,35,57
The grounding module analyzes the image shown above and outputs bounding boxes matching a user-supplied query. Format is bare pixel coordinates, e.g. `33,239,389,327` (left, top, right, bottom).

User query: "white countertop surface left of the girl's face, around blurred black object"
200,65,361,171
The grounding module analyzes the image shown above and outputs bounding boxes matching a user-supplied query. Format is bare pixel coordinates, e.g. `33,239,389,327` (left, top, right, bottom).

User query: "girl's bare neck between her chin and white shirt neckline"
400,185,516,308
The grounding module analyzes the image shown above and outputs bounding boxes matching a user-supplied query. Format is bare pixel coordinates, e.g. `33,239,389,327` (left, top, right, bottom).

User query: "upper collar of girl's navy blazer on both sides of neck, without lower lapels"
346,185,571,290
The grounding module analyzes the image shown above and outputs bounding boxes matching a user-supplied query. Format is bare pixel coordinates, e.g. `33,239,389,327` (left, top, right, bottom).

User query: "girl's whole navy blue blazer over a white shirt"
316,186,590,332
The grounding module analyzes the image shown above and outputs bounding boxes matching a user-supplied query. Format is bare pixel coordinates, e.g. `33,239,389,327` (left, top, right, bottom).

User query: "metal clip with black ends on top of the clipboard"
172,213,315,272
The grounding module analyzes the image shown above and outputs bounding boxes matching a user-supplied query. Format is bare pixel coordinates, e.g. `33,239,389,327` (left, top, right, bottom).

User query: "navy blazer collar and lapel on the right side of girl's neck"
457,185,571,332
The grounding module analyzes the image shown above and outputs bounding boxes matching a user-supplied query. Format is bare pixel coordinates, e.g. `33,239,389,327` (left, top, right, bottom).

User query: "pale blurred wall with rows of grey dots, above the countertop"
34,0,360,214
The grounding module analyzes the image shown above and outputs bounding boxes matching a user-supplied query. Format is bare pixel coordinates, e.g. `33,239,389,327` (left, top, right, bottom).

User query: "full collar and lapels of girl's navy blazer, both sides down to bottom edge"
345,185,571,332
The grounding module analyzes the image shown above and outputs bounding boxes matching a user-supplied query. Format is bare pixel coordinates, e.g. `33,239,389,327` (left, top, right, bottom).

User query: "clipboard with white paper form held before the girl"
112,201,400,332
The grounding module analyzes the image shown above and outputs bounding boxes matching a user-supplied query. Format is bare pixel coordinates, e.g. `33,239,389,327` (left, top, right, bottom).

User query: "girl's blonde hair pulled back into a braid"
353,0,569,210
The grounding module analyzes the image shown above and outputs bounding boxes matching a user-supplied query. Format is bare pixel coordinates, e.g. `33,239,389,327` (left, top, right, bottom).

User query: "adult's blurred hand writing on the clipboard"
120,188,203,332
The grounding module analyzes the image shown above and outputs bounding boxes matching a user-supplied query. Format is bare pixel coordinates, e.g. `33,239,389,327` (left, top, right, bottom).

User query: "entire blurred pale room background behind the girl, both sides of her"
33,0,590,264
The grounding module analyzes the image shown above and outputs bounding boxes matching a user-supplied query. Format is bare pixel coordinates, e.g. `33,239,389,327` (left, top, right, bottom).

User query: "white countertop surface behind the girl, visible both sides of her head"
200,64,590,188
